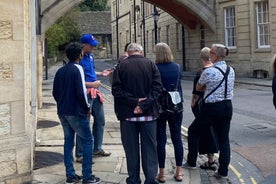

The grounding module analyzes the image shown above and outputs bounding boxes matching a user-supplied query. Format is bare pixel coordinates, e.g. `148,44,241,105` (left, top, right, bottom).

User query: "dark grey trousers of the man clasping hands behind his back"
120,120,158,184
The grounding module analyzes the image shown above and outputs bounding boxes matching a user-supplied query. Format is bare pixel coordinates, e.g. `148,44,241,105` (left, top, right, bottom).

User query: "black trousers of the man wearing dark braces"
187,100,233,176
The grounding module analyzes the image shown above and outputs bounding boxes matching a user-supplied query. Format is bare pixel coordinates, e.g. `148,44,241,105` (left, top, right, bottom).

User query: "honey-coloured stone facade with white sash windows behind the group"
111,0,276,78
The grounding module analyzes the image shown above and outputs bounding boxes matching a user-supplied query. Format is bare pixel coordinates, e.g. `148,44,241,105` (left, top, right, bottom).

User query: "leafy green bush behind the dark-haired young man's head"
46,11,81,57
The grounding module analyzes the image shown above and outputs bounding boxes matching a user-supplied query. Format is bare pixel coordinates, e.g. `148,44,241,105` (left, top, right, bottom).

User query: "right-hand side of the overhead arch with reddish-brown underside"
145,0,216,32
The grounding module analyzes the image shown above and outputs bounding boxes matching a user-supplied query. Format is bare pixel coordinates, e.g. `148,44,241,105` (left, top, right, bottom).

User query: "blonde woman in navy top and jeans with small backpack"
155,43,183,183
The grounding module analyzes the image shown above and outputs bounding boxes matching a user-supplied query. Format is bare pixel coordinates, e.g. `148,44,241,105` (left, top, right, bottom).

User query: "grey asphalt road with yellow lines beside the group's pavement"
95,60,276,184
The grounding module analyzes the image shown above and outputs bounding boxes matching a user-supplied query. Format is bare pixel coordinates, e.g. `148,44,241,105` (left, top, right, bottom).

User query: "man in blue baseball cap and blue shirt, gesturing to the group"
76,34,112,162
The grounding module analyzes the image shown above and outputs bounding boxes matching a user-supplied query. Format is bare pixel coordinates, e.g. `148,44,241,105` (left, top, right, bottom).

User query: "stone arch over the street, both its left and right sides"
41,0,215,35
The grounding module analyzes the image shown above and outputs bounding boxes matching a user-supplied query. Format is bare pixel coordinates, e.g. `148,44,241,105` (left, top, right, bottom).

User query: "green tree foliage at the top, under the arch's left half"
79,0,110,11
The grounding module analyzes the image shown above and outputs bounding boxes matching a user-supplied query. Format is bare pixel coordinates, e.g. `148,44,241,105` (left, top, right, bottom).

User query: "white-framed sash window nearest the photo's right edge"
255,1,270,48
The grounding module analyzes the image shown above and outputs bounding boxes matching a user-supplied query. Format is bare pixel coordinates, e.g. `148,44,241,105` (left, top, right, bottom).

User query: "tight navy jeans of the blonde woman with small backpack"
157,112,183,168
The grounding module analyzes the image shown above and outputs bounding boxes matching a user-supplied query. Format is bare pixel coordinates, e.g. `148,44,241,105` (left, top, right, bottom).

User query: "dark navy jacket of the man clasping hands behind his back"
112,55,162,120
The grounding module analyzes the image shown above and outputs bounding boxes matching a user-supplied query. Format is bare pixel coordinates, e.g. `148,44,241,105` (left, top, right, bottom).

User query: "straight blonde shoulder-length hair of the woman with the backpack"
155,43,174,63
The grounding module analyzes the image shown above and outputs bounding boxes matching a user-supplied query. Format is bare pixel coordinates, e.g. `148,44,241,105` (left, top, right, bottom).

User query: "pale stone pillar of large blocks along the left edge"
0,0,33,183
